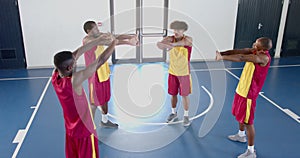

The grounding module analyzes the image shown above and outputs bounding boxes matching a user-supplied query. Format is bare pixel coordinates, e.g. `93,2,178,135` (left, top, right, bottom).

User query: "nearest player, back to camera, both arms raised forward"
52,35,118,158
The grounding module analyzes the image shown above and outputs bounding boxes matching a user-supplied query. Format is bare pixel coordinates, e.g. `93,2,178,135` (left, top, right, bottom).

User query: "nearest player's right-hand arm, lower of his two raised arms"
72,40,118,94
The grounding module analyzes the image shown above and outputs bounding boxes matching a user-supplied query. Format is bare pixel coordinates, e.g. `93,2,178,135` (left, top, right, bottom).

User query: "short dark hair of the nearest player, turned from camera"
54,51,73,70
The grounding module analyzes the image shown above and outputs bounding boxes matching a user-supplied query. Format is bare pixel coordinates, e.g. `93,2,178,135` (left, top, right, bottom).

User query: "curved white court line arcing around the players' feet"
103,86,214,126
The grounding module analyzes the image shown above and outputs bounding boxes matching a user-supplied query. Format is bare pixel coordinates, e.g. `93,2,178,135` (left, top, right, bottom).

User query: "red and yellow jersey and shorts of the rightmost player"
232,51,271,125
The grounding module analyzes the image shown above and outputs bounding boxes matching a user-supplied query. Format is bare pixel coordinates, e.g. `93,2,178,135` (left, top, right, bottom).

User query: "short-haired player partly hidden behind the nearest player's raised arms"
83,21,138,128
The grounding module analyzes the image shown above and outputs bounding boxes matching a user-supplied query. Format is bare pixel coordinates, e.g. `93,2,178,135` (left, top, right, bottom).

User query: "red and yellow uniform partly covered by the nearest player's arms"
84,46,111,106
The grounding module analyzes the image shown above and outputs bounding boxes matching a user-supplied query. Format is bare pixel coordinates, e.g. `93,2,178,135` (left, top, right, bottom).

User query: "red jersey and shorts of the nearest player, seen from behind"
52,70,99,158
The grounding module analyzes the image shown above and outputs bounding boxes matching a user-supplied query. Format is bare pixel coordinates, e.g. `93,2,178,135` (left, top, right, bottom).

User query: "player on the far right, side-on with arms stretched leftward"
216,37,272,158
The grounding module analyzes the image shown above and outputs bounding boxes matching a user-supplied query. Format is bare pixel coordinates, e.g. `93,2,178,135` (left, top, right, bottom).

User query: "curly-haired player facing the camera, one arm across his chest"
157,21,192,126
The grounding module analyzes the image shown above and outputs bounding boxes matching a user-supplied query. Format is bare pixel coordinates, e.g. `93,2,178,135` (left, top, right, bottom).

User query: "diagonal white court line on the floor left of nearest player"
12,77,51,158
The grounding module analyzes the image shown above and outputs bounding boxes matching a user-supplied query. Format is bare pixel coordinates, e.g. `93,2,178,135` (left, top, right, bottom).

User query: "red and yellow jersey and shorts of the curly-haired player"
168,36,192,96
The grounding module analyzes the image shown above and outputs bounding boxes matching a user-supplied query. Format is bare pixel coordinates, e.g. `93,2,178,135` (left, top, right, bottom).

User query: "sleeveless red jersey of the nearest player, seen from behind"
52,70,96,137
